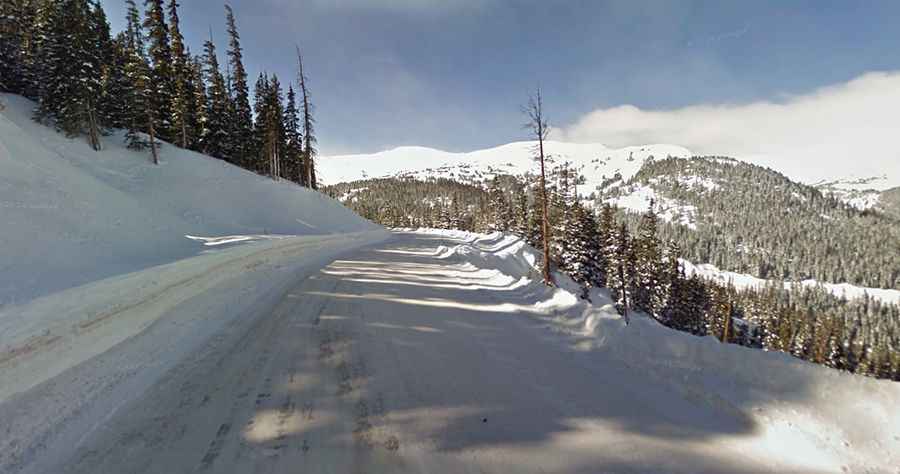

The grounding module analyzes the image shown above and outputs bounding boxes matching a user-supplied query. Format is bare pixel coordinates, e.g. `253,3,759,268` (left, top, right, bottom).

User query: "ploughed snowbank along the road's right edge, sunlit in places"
414,229,900,472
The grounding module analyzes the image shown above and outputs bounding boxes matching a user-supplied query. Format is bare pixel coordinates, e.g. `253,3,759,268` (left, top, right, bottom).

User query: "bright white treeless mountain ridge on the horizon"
319,141,691,196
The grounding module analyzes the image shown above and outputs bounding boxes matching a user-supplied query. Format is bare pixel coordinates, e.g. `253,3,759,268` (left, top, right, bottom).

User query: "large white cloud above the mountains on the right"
556,72,900,188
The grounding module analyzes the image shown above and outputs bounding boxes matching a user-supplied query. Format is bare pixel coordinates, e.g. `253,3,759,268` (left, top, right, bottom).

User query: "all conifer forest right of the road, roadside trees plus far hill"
327,158,900,380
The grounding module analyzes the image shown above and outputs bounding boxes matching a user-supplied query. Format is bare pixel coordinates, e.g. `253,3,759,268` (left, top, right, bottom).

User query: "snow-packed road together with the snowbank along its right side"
0,231,900,474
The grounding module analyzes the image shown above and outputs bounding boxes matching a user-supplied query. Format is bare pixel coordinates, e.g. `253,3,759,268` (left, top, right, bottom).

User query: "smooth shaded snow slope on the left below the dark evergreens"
0,95,377,307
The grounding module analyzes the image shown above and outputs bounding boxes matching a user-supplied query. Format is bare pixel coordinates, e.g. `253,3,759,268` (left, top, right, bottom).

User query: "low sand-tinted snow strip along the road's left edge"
0,230,389,402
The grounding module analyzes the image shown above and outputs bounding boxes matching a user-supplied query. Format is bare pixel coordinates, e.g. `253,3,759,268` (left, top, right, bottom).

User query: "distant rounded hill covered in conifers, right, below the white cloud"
599,157,900,289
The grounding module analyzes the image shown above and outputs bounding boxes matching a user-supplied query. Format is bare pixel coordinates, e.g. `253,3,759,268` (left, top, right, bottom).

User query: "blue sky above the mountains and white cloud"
103,0,900,154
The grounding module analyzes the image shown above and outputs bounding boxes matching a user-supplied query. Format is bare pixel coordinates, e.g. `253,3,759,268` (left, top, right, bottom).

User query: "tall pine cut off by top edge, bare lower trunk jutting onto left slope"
144,0,177,142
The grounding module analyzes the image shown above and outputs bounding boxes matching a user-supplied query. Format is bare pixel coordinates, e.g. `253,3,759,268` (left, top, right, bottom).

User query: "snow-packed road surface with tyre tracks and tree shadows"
0,234,892,474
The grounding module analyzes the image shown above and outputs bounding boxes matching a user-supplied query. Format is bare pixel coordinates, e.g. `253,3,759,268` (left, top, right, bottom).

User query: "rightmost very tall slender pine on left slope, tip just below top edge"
225,4,251,167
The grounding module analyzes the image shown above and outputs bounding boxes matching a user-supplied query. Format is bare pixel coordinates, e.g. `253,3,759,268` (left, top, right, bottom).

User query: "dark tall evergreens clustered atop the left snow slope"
0,0,317,188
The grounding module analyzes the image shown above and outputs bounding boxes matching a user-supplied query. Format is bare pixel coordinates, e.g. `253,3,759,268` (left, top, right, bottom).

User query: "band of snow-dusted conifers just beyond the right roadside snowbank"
327,174,900,380
